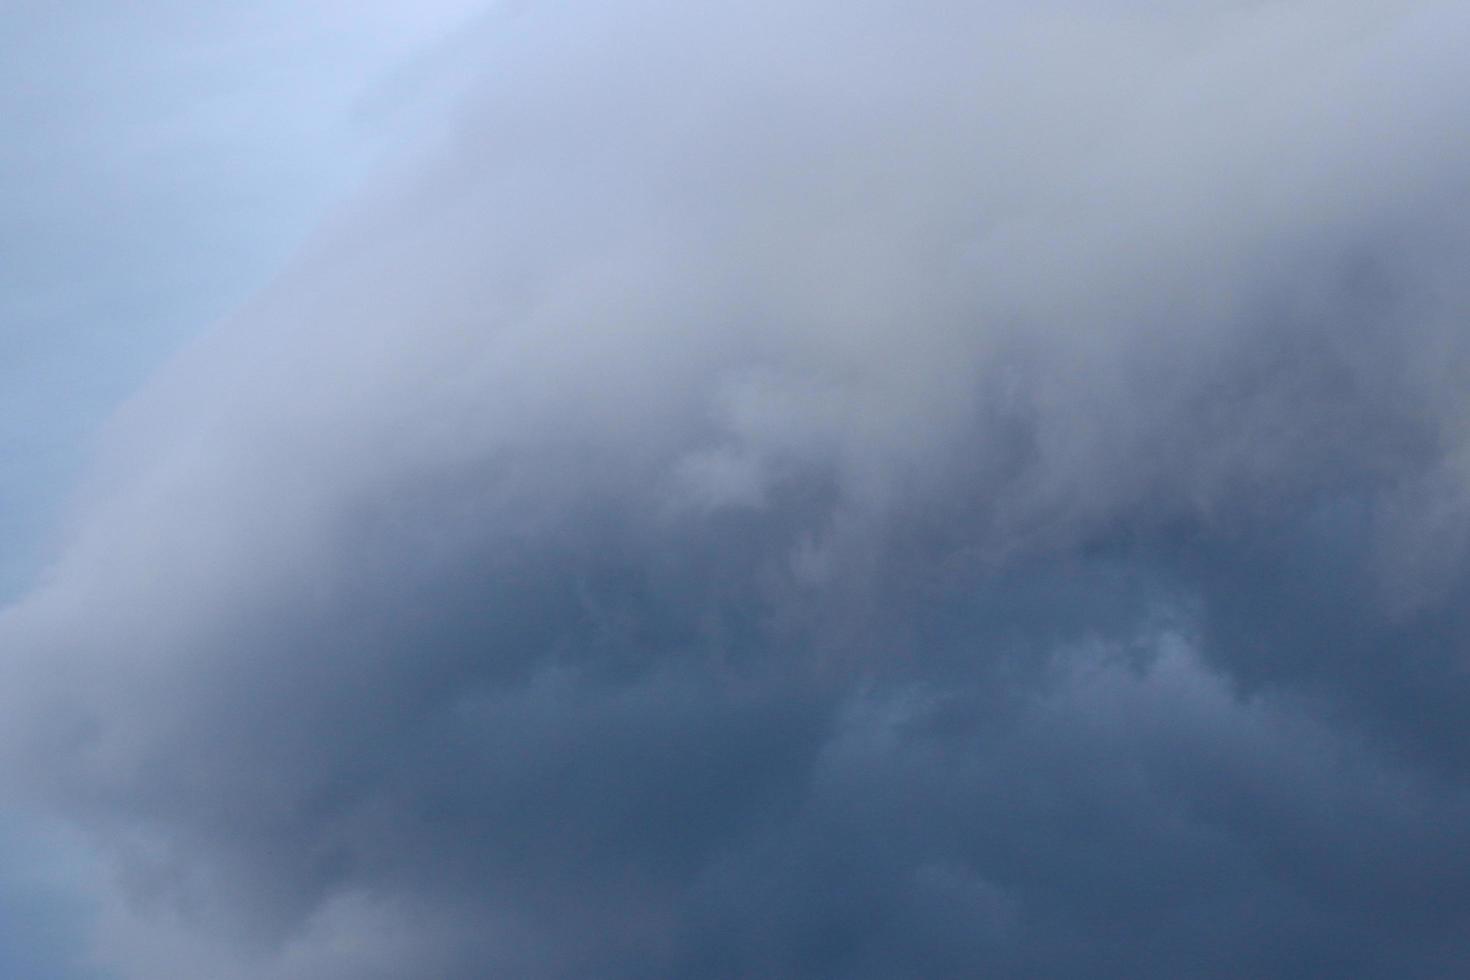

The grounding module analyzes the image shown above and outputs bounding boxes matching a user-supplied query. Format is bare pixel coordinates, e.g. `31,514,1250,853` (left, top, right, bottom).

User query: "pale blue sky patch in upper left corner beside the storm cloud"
0,0,479,601
